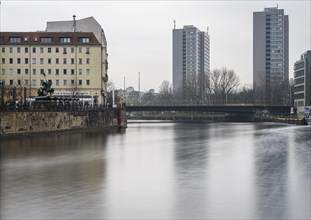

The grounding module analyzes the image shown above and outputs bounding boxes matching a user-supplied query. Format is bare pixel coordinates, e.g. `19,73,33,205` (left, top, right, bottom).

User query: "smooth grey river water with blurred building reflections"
0,121,311,219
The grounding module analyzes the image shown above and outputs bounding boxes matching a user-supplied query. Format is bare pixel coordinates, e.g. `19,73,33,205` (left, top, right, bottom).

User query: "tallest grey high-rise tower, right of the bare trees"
253,7,289,105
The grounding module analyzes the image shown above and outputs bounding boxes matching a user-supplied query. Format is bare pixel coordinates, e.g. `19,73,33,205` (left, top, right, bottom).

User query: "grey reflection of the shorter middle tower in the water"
174,124,209,219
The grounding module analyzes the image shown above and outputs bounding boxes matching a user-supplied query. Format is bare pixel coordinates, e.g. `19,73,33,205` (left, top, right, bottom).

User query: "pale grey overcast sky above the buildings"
0,0,311,91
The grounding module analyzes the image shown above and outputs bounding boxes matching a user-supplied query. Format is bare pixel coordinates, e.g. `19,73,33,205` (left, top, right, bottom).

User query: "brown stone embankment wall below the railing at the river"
0,109,127,136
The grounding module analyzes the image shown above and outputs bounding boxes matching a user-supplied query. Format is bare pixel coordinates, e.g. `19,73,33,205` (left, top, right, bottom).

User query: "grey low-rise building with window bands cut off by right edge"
294,50,311,116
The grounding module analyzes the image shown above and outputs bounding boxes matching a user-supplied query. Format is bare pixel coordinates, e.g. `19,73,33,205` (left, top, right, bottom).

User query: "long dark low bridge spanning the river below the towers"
126,105,291,115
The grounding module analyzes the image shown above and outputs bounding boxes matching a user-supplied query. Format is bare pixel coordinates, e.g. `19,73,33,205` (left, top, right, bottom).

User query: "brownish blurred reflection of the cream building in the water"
1,132,106,219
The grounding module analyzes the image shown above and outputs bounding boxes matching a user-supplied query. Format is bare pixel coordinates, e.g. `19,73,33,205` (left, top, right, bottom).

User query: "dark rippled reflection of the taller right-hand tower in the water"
254,124,292,219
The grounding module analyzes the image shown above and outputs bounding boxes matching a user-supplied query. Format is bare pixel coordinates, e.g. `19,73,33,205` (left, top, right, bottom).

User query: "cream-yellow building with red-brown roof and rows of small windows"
0,32,103,103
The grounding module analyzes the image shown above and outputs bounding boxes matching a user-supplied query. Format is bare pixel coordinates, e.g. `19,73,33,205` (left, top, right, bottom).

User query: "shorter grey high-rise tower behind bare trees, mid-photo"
173,25,210,101
